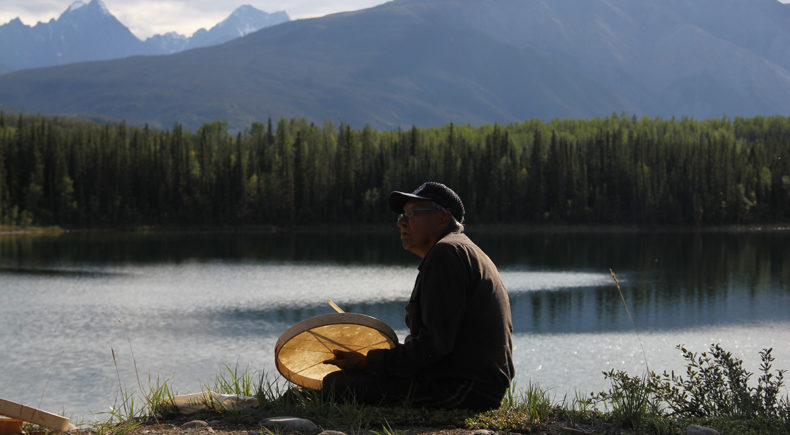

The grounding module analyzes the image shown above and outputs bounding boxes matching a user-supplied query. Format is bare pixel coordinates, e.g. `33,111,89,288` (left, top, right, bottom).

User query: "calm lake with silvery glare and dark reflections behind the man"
0,228,790,421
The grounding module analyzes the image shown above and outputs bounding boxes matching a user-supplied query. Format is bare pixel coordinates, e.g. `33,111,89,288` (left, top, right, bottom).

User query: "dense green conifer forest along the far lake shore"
0,113,790,227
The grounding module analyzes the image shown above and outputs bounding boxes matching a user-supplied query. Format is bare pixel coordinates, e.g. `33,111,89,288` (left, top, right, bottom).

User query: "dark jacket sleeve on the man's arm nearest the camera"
368,243,471,376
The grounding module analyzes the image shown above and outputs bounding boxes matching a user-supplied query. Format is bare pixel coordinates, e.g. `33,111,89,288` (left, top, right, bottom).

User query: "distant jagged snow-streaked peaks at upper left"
0,0,290,74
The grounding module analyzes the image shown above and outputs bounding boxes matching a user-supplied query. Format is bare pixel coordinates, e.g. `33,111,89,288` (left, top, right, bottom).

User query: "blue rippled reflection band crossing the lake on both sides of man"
102,285,790,338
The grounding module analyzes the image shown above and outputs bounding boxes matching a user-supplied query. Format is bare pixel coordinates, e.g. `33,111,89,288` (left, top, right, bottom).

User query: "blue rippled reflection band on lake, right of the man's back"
510,285,790,334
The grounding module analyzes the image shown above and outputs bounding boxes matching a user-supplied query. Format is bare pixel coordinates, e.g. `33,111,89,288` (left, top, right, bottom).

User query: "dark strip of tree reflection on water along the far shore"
0,228,790,278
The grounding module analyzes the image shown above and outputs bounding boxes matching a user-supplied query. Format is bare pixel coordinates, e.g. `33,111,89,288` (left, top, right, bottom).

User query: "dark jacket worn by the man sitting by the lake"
367,232,515,400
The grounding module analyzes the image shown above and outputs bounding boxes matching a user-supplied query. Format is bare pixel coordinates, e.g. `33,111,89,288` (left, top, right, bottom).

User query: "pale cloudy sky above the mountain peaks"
0,0,390,39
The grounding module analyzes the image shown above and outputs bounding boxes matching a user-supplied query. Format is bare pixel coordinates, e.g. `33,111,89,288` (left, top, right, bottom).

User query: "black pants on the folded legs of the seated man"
321,371,504,411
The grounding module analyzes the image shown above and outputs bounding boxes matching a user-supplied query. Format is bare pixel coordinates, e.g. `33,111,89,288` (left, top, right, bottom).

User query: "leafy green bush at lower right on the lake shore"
591,344,790,433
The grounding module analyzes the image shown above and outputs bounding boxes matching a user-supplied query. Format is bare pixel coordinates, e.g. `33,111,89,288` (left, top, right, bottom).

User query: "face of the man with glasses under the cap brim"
398,200,449,258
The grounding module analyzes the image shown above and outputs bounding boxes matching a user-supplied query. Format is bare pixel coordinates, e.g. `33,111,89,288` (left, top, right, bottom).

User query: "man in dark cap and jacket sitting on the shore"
322,182,515,410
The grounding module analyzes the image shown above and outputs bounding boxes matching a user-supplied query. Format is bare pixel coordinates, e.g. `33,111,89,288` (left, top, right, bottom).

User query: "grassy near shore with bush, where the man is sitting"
48,344,790,435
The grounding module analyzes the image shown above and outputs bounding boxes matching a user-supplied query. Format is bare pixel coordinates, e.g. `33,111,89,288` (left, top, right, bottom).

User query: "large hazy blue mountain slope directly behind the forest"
0,0,790,128
